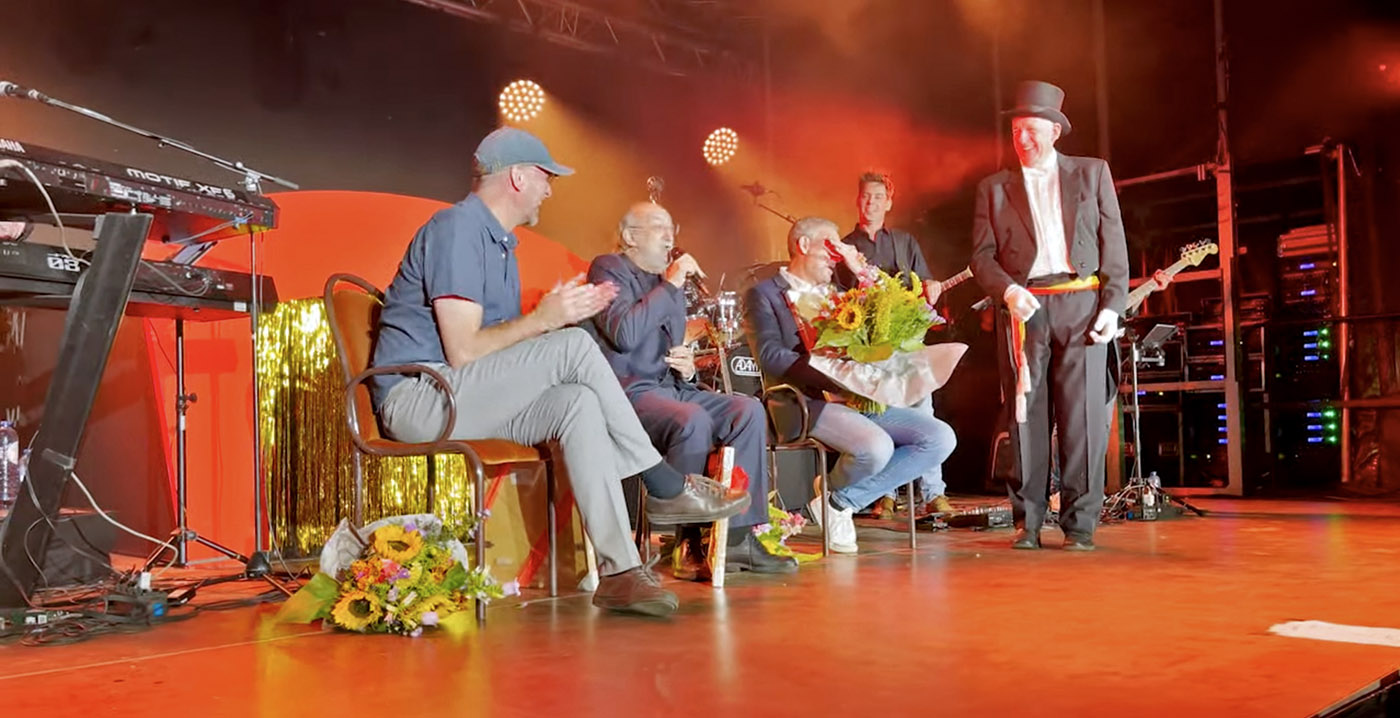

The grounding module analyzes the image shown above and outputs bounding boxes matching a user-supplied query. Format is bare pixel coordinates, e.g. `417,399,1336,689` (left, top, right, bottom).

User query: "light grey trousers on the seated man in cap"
379,329,661,575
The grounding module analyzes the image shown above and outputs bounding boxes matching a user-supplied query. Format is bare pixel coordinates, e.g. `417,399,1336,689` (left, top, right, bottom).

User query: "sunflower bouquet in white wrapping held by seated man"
811,270,967,413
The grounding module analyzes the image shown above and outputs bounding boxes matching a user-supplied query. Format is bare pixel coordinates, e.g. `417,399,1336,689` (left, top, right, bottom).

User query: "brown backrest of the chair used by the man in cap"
325,274,384,441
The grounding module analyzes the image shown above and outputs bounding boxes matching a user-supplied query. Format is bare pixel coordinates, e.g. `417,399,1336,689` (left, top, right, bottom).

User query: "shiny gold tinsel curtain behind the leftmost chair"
256,298,472,556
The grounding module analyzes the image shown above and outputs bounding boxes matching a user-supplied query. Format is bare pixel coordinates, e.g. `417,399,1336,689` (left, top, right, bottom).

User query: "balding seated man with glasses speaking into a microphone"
585,202,797,578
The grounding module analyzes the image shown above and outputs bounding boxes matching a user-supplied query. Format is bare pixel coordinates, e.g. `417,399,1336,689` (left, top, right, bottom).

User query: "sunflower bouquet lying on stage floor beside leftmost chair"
279,515,519,637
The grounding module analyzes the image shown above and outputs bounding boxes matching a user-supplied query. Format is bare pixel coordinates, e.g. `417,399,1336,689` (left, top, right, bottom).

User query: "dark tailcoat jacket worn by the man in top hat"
970,154,1128,316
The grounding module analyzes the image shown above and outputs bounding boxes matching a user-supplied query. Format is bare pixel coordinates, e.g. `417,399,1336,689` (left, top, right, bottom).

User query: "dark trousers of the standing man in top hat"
997,290,1109,535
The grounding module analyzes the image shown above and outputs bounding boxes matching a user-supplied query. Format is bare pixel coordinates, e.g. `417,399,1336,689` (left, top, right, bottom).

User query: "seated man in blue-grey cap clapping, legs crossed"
371,127,749,616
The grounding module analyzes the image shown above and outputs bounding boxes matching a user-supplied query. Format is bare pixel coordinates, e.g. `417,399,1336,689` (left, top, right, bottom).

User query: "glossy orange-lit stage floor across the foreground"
0,500,1400,718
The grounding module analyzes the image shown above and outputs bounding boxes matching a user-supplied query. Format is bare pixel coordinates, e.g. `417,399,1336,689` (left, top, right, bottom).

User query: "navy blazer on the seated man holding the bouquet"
743,274,844,430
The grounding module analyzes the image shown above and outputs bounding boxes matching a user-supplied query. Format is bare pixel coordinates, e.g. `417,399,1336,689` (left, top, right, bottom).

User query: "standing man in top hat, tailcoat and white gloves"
972,83,1128,551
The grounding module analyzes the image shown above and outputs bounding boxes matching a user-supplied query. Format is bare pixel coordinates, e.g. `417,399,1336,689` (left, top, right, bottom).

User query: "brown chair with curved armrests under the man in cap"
325,274,559,624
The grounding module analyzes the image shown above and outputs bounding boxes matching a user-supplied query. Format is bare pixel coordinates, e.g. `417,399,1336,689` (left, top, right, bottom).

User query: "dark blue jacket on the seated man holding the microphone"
582,255,686,396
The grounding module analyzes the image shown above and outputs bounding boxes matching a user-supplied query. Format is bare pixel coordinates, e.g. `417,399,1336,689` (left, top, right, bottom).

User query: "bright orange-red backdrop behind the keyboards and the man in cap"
146,192,588,558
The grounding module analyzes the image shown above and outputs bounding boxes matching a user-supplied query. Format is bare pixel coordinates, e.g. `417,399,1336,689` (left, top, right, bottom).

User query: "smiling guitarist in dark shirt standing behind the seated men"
836,172,953,514
